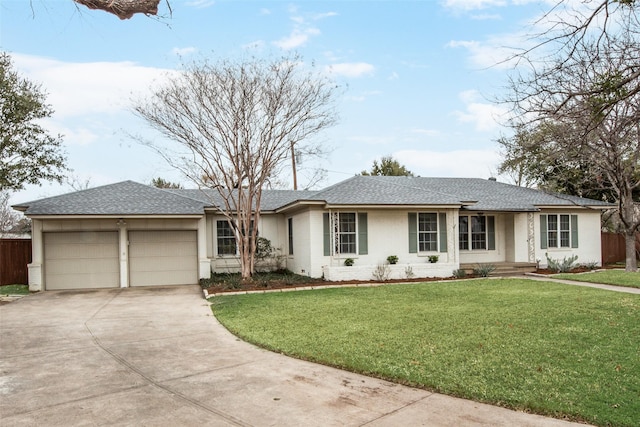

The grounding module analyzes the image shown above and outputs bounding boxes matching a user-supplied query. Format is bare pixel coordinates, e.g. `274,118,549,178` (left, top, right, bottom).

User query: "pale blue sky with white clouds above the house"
0,0,555,203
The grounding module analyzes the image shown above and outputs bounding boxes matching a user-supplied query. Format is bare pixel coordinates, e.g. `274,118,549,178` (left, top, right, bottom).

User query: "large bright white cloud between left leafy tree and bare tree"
12,54,170,119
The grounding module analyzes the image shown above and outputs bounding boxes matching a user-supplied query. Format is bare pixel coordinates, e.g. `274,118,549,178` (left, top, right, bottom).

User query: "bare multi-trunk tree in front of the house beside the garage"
134,56,337,279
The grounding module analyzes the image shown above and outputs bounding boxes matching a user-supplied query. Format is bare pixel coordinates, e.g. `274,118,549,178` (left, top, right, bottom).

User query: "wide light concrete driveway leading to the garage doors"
0,286,583,427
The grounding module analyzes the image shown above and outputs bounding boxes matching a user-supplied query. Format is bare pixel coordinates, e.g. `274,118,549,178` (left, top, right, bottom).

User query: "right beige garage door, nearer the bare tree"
129,231,198,286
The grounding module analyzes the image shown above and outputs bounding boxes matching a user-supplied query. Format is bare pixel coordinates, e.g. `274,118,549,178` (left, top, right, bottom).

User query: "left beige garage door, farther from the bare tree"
44,231,120,290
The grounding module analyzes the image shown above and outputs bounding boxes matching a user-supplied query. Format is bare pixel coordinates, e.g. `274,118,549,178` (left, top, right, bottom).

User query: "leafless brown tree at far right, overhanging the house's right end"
501,0,640,271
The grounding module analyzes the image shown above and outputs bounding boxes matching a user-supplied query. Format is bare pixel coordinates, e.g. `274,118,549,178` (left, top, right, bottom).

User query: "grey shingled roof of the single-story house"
14,176,612,215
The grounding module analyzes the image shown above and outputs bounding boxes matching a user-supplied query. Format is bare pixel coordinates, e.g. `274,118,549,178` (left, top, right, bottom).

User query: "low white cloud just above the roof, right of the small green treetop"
393,149,500,178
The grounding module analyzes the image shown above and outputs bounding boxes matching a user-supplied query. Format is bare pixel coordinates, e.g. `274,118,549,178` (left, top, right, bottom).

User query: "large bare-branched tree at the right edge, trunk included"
503,15,640,271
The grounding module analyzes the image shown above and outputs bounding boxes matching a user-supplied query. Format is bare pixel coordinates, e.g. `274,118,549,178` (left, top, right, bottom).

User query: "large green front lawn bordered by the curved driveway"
211,279,640,426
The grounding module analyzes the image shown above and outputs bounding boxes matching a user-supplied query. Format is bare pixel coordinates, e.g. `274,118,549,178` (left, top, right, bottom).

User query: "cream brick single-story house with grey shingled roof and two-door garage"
14,176,611,290
